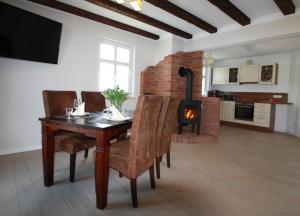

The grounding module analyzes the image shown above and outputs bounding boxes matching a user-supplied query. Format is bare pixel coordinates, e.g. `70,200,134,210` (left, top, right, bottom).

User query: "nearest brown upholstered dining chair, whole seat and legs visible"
94,96,163,208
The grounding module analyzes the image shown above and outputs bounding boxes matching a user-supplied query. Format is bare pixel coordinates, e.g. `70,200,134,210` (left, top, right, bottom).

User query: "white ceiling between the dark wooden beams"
59,0,300,37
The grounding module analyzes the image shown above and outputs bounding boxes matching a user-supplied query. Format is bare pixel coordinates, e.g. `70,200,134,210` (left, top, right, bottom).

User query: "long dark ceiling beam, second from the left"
86,0,193,39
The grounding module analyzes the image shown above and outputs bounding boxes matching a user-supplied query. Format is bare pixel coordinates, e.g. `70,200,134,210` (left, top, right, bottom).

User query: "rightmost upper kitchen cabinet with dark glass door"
259,64,278,85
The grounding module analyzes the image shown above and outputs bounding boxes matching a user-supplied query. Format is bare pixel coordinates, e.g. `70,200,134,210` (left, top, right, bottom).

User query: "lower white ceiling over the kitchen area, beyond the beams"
205,36,300,60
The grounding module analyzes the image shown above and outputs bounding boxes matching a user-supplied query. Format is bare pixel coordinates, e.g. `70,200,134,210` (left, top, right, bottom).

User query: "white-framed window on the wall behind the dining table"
99,41,133,93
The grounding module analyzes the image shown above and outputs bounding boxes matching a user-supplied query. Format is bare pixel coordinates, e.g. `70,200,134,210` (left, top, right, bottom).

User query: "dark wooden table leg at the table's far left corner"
42,123,55,187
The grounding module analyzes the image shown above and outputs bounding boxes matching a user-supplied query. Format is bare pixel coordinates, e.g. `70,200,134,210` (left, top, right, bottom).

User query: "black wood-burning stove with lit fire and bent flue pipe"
178,67,202,134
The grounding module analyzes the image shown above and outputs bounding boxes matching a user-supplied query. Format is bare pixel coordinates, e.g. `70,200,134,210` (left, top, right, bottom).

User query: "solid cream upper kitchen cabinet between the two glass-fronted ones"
239,64,260,83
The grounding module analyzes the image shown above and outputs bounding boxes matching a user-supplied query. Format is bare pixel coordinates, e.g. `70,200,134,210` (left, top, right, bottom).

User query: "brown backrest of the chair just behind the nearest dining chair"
156,97,180,157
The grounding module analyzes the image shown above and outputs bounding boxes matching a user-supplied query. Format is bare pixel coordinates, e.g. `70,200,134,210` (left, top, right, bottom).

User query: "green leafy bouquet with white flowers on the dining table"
102,85,129,110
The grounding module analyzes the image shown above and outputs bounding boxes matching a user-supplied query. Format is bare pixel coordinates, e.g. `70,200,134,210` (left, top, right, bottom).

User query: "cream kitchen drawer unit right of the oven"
254,103,272,127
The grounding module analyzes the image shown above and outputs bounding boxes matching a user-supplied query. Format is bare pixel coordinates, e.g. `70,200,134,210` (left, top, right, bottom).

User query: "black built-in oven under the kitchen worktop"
234,102,254,121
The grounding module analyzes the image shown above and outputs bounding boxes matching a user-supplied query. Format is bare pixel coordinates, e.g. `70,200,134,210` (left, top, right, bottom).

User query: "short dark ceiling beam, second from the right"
208,0,251,26
